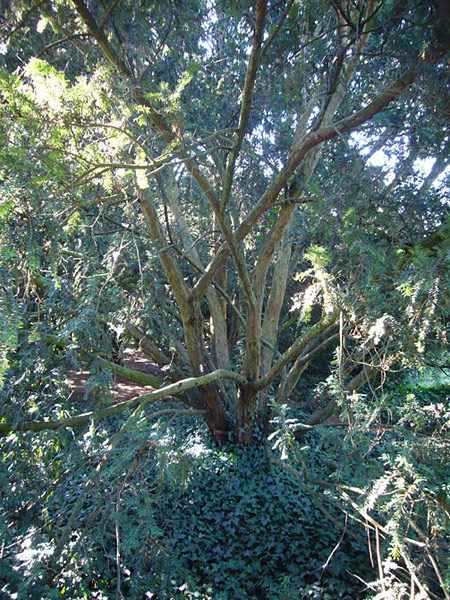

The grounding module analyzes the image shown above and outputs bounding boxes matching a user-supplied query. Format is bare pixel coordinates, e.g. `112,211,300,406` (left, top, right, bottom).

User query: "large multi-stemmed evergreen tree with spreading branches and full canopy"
0,0,450,444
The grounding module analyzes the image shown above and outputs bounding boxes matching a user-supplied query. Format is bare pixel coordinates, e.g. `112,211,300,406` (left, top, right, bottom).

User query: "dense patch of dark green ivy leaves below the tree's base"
149,448,370,598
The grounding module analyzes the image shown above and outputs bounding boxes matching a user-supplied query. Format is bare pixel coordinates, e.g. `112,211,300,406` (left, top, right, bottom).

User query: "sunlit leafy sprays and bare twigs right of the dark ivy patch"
271,372,450,598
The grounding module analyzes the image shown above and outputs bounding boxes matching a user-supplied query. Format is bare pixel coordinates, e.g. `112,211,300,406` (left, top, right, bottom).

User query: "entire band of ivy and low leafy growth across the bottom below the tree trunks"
0,382,450,600
